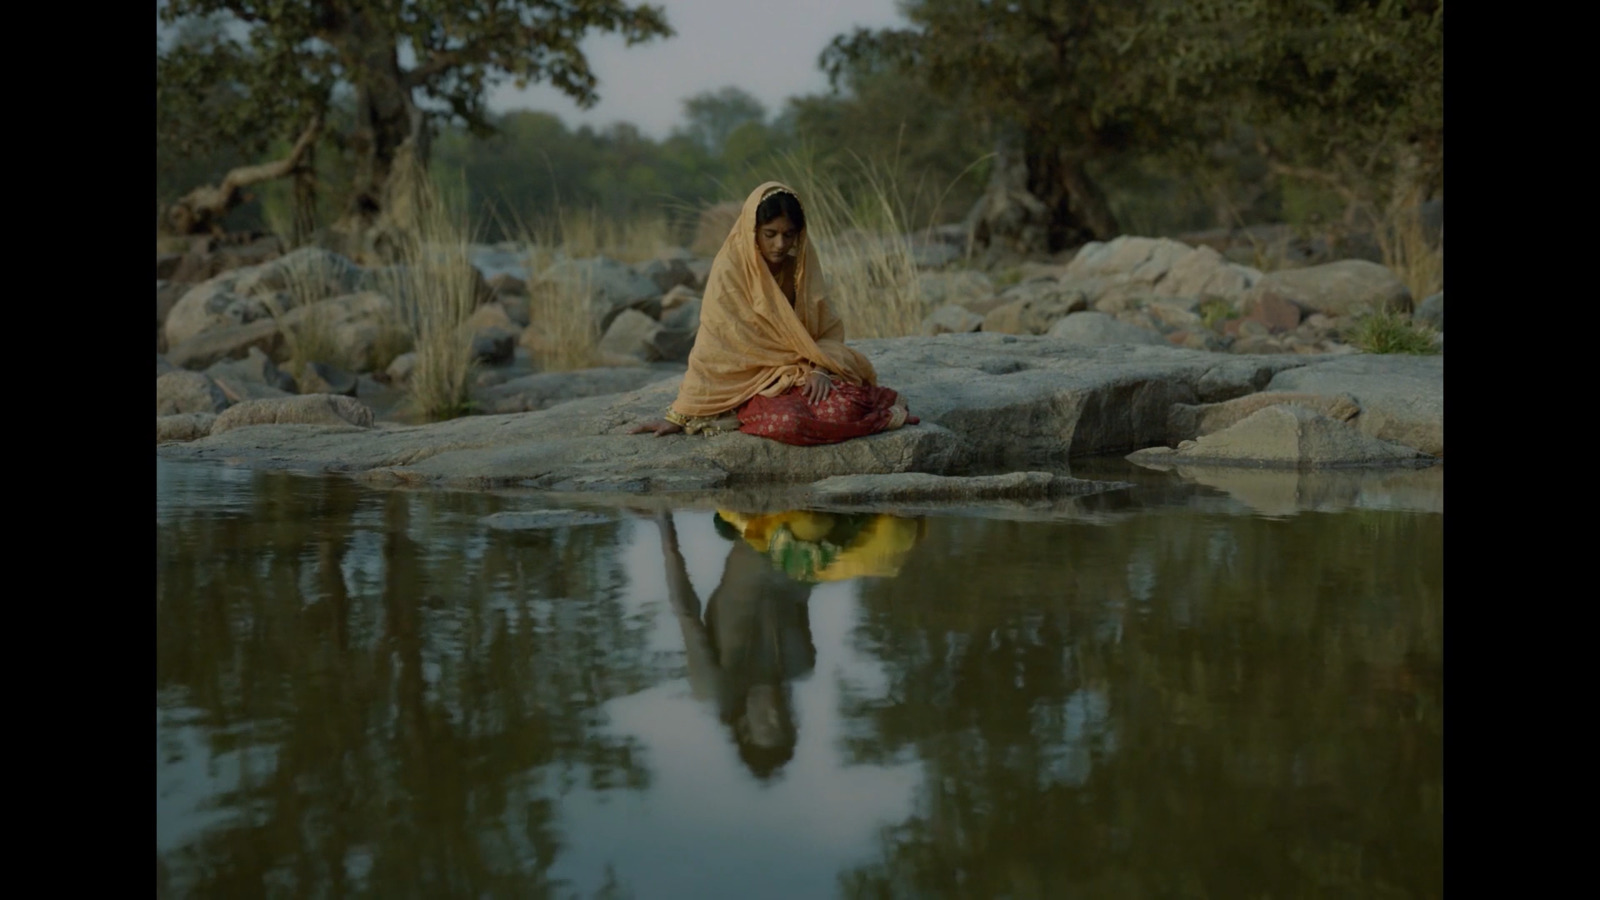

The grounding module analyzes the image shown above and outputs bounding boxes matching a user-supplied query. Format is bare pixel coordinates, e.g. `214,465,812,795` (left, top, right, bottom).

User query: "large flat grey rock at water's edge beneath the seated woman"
157,333,1443,492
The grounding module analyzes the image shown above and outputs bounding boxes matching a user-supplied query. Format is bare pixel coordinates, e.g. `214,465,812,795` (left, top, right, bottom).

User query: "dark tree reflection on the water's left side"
157,477,654,897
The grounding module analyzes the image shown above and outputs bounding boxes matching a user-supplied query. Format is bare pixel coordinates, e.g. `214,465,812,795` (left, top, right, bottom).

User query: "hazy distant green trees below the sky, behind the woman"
432,68,986,243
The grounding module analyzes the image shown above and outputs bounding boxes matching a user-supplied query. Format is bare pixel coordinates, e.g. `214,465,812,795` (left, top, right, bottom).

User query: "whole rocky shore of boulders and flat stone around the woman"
157,229,1445,498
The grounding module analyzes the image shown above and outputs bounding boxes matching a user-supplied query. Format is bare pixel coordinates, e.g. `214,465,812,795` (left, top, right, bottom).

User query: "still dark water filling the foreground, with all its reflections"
155,460,1443,898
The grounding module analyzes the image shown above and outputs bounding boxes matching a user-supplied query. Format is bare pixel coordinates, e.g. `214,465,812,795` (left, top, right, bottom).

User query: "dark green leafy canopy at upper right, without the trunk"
822,0,1443,241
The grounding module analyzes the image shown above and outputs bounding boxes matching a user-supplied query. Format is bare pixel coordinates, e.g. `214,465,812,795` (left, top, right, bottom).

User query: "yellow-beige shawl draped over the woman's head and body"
672,181,877,418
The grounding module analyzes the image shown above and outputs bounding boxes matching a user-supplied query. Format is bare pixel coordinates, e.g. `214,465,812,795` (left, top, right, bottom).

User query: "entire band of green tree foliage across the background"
157,0,1443,249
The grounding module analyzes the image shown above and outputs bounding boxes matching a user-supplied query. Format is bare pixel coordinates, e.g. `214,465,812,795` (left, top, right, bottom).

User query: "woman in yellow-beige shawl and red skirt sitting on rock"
632,181,918,445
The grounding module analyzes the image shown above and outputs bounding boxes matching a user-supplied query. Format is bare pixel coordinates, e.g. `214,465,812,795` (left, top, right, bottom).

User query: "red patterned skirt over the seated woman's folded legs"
739,381,918,447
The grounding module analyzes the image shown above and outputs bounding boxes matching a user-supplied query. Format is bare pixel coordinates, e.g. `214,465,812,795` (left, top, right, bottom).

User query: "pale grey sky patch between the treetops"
488,0,906,138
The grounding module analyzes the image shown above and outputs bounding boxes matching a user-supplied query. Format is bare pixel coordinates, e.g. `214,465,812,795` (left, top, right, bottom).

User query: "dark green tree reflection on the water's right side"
840,511,1443,897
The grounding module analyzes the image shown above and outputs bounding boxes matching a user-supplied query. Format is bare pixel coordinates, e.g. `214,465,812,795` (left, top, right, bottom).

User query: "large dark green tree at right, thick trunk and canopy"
821,0,1443,251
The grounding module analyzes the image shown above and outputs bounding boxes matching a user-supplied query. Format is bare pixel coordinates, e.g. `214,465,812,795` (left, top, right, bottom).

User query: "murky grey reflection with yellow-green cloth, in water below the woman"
656,511,923,778
